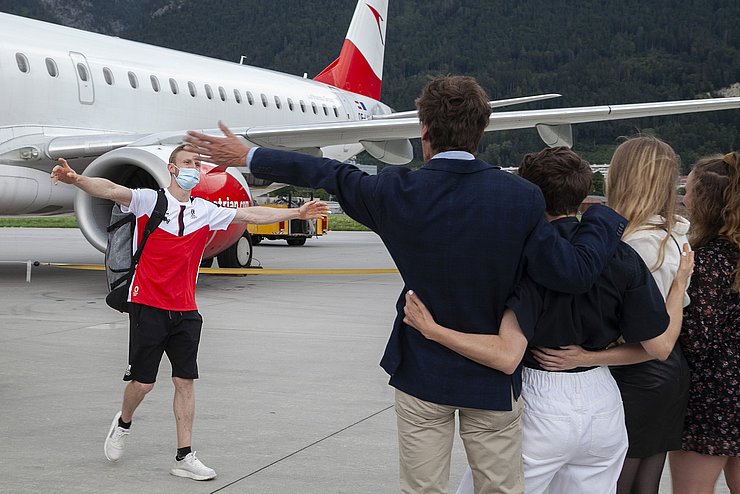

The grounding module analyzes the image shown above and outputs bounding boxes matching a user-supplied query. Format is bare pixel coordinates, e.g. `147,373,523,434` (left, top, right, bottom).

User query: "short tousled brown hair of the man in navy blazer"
416,76,491,153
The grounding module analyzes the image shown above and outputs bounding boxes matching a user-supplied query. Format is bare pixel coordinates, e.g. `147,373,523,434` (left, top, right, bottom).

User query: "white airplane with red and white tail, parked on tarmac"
0,0,740,267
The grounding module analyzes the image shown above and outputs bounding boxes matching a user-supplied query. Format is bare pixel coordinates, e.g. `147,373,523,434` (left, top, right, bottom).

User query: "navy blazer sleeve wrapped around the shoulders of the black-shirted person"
524,189,627,293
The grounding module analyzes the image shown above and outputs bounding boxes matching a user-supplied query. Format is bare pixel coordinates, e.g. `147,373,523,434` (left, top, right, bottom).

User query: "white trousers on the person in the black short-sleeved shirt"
457,367,627,494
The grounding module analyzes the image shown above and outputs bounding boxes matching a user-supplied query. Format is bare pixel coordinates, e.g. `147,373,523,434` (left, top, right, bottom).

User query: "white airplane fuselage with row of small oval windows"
0,14,391,215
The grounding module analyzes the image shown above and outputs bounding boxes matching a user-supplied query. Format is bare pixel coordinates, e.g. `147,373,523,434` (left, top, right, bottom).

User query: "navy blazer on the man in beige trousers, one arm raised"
250,148,626,410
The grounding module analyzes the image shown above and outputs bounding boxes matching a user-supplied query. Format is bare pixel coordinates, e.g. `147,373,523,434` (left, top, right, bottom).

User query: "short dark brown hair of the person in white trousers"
519,147,593,216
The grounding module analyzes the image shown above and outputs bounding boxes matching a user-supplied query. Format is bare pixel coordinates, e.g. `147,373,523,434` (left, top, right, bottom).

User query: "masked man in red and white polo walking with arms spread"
51,146,328,480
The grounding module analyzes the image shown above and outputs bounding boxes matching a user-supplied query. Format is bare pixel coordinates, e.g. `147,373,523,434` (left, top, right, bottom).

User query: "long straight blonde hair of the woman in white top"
606,136,679,271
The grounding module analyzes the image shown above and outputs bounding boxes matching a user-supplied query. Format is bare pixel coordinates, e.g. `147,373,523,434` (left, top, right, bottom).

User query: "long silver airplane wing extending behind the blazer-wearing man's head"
46,97,740,158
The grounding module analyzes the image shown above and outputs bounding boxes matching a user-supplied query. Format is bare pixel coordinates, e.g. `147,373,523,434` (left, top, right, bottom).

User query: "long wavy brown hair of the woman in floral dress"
689,152,740,292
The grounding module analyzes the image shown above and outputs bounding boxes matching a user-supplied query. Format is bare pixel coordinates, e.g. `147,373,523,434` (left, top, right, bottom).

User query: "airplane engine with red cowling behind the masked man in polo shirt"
75,146,252,267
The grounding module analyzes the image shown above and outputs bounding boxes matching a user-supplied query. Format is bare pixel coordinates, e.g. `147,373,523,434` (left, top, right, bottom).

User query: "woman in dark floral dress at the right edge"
670,152,740,494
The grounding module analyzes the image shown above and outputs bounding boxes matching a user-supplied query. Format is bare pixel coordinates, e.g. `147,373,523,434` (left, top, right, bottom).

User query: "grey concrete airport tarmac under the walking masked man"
0,228,729,494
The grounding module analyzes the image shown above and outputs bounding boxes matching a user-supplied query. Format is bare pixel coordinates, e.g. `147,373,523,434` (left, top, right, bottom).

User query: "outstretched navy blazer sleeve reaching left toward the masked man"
249,148,378,230
